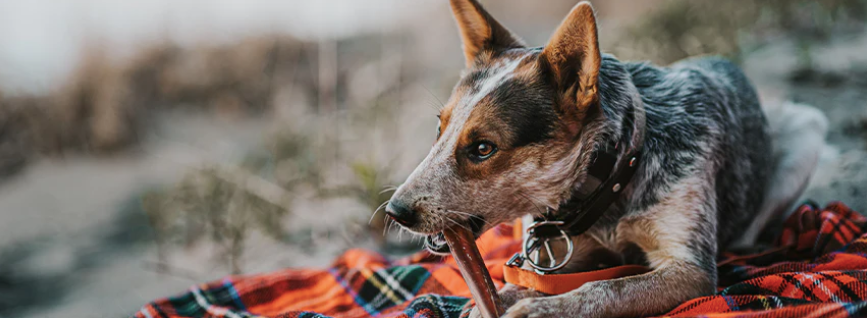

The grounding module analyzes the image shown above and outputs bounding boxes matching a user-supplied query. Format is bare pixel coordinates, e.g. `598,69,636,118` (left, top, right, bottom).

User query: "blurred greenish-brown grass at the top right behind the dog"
614,0,867,67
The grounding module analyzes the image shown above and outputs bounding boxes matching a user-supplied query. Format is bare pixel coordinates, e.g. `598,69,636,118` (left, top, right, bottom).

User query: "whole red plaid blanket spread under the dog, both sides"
135,203,867,318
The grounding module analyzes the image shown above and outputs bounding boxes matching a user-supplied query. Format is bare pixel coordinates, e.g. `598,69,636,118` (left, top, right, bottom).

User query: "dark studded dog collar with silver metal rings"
506,103,645,274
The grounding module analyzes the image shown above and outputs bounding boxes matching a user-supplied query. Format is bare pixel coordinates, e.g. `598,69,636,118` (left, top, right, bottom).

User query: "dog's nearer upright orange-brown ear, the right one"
542,2,602,111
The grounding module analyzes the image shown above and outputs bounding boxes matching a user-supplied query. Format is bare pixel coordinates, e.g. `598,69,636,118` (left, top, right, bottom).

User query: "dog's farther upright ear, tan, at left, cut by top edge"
451,0,524,67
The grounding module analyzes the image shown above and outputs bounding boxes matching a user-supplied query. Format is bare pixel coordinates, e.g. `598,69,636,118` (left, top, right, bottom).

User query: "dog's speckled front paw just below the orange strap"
503,295,602,318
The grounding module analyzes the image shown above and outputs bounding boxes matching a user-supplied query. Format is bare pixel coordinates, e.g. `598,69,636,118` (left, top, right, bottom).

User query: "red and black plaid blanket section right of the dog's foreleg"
667,202,867,318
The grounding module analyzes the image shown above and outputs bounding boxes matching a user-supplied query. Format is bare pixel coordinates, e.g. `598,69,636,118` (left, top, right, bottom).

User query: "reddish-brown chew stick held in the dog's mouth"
443,227,505,318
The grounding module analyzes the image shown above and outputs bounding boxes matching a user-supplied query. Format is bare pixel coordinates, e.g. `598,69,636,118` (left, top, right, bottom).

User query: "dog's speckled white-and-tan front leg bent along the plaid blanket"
504,182,717,317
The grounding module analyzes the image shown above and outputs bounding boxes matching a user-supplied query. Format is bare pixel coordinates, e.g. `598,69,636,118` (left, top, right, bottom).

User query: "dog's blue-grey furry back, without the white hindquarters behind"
627,57,773,248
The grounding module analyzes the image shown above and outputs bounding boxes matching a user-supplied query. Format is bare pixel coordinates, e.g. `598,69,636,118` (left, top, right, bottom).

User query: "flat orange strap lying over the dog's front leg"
503,265,650,295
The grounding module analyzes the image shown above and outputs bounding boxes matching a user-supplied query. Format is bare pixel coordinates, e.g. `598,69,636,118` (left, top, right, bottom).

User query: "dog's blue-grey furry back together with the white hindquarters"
627,57,827,248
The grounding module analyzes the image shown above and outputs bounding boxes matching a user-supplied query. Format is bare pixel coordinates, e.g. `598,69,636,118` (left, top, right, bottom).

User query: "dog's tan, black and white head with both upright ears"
386,0,602,241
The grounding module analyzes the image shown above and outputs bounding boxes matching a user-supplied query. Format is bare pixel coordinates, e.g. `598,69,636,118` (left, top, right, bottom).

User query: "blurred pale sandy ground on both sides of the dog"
0,24,867,318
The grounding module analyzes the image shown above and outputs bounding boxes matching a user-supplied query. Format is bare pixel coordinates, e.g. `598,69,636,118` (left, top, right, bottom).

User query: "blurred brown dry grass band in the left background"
0,37,315,161
